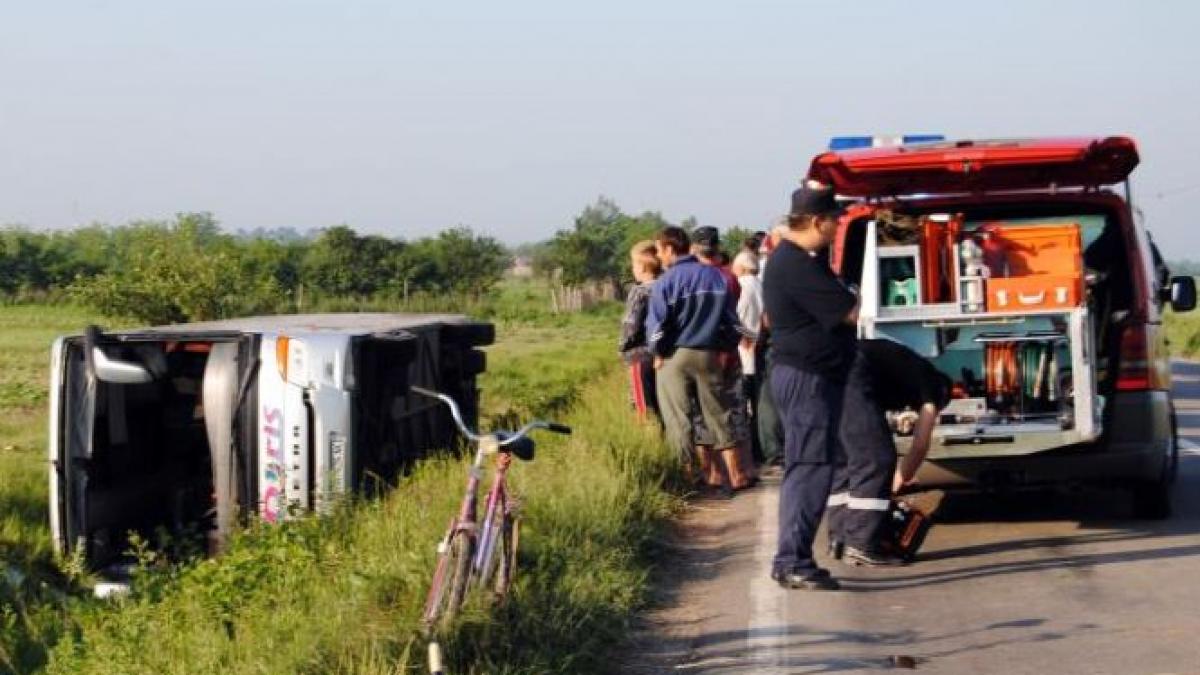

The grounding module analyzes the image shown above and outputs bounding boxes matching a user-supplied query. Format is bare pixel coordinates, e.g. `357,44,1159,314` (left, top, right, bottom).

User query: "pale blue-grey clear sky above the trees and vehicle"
0,0,1200,253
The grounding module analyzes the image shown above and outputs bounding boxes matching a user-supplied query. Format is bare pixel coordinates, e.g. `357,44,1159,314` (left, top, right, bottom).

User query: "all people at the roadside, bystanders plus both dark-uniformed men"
619,184,949,590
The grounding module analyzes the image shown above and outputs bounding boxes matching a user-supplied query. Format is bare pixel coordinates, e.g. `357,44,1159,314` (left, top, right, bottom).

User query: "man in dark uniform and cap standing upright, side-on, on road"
763,181,858,590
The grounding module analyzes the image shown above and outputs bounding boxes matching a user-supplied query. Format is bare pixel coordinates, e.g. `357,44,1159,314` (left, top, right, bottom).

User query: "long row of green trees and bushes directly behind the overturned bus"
0,213,511,323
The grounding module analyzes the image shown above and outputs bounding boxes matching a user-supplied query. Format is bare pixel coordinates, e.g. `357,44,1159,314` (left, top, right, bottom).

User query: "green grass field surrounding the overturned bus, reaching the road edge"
0,290,678,674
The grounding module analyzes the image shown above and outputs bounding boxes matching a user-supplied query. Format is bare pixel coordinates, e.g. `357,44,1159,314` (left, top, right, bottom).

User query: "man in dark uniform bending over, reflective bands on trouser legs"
828,340,950,566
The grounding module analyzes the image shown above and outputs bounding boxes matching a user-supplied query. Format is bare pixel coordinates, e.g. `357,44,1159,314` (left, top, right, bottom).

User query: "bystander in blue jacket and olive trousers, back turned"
646,226,740,488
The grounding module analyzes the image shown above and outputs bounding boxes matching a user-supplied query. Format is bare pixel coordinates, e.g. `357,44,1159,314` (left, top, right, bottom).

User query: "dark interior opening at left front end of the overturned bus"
67,341,234,569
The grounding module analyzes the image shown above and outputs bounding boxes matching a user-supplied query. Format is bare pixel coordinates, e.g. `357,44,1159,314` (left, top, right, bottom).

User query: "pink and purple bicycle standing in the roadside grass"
409,387,571,675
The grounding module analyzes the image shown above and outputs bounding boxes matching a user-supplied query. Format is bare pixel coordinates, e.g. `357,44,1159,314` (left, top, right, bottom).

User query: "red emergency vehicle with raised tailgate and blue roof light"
808,137,1195,518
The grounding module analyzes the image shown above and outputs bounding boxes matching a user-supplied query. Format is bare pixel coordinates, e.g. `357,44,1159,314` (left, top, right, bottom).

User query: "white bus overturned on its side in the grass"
49,313,494,575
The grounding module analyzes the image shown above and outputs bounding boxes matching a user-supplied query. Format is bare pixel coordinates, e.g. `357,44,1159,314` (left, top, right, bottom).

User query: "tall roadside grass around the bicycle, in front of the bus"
49,367,672,674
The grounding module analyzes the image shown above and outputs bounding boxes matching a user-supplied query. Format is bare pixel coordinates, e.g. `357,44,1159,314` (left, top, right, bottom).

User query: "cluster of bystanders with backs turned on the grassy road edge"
619,227,781,495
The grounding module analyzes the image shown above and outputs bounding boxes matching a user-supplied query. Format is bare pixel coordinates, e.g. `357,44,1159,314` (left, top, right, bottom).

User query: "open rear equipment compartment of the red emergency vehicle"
840,204,1130,458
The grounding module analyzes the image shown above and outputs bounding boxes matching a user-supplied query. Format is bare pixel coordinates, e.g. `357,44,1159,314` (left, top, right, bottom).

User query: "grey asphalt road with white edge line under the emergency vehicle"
619,363,1200,675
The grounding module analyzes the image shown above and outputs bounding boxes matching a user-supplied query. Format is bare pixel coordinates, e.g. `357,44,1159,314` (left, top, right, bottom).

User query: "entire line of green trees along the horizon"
0,197,749,324
